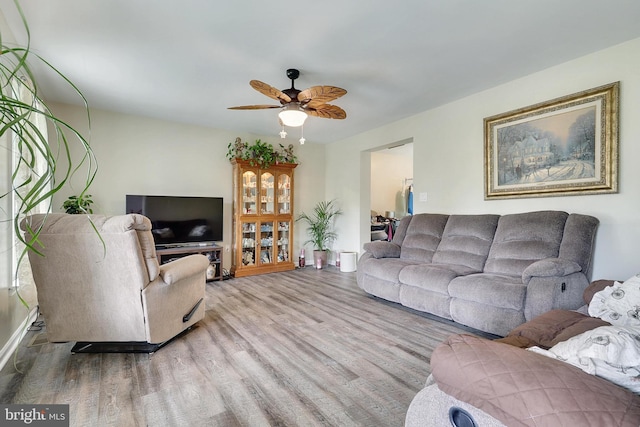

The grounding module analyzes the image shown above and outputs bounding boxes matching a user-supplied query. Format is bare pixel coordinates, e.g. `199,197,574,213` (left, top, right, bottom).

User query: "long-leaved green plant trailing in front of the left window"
0,0,97,294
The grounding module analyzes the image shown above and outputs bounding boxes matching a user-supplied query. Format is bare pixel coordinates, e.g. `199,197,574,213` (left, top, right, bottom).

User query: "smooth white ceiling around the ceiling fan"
0,0,640,142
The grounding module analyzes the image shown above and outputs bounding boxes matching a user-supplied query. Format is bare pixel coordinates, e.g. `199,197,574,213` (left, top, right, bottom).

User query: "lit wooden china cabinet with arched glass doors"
231,159,298,277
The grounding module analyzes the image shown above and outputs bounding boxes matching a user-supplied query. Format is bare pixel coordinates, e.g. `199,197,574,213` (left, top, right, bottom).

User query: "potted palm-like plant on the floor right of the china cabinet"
296,200,342,267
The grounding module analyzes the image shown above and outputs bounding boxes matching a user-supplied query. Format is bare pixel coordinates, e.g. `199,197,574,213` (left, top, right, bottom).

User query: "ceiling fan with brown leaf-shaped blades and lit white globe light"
229,68,347,127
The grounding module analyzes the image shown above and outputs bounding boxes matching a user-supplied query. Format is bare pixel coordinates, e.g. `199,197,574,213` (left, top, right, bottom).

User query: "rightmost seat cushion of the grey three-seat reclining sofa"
449,273,527,311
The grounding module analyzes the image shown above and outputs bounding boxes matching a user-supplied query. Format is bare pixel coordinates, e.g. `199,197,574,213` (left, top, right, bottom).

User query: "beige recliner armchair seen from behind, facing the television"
21,214,209,352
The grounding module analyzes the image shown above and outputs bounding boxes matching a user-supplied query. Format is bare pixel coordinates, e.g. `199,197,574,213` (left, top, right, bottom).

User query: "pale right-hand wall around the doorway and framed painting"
326,39,640,279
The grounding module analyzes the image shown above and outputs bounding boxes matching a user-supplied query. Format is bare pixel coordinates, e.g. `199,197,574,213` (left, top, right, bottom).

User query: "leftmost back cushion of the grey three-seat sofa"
400,214,448,262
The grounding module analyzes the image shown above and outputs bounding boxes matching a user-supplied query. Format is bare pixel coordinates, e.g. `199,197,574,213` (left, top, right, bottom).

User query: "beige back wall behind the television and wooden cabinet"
51,104,325,268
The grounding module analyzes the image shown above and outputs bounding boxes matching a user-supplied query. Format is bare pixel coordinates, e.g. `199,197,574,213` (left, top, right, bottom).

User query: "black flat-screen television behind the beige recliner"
126,194,223,248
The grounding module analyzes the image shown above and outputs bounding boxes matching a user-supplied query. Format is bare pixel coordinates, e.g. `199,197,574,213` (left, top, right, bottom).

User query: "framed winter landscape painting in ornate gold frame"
484,82,620,200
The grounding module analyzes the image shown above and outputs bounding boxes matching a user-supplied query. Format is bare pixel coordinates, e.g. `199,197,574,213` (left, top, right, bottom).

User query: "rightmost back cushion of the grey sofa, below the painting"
484,211,569,276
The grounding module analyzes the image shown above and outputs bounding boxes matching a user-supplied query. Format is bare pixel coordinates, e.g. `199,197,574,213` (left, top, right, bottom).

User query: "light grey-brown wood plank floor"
0,267,480,427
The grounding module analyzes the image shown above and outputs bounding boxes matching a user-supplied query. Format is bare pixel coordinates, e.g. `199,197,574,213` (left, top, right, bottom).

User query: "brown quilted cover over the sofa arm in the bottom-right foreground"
431,335,640,427
